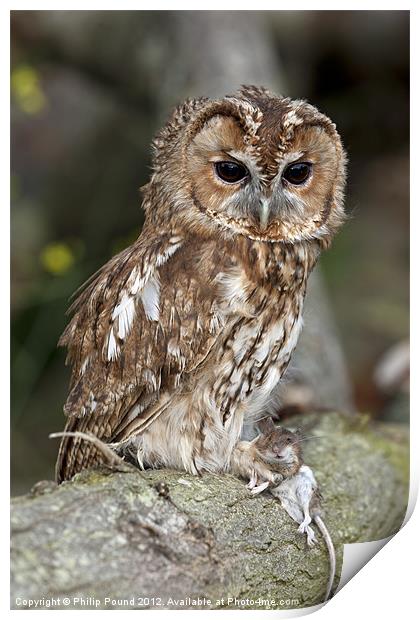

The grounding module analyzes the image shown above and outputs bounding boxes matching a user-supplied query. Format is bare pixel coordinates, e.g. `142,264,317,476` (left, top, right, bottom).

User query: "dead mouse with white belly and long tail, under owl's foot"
248,418,336,601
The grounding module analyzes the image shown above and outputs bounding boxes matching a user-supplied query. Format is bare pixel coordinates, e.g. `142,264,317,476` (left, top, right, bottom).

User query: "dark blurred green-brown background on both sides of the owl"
11,11,409,493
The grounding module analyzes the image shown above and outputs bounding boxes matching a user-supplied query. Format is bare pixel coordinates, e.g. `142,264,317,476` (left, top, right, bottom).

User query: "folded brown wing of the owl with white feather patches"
56,230,223,481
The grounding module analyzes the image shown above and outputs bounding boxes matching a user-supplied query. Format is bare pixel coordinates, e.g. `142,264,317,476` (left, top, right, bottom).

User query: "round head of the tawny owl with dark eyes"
144,86,346,243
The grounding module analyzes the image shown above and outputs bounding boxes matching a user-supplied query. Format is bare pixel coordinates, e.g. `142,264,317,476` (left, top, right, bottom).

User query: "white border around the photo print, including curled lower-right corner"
4,0,420,620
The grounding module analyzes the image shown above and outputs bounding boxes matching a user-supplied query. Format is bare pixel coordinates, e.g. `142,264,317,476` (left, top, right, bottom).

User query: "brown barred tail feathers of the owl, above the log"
49,431,132,483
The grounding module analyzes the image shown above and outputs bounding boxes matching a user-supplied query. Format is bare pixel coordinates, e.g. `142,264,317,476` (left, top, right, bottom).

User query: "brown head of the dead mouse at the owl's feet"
255,417,302,465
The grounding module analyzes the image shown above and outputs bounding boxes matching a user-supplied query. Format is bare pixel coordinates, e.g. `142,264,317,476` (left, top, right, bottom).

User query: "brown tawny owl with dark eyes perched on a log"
56,86,346,481
